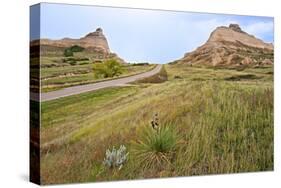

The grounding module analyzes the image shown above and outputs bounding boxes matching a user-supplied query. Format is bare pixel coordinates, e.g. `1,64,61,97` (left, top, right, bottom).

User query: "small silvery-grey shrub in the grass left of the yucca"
103,145,129,170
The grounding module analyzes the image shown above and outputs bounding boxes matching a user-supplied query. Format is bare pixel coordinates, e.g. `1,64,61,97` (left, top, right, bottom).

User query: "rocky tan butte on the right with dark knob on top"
176,24,274,66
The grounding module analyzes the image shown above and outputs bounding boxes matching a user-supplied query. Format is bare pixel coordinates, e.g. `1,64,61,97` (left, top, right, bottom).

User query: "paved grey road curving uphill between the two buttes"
34,65,162,102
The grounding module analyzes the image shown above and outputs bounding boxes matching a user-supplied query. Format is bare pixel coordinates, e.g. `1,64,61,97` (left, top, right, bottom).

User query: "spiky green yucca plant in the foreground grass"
132,116,178,169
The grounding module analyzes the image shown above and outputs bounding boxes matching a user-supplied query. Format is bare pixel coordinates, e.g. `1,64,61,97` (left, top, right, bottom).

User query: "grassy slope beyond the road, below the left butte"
37,47,155,92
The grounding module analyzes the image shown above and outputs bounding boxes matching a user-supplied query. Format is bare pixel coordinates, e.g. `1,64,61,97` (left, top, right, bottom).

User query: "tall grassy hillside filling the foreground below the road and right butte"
41,65,273,184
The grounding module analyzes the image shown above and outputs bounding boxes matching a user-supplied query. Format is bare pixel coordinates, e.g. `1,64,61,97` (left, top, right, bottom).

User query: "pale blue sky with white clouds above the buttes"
30,3,274,63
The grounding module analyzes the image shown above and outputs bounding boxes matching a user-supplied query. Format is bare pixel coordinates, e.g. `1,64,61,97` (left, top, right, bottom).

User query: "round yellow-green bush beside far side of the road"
93,59,123,78
